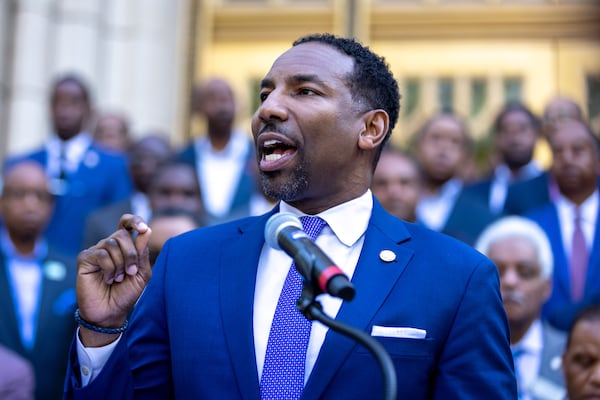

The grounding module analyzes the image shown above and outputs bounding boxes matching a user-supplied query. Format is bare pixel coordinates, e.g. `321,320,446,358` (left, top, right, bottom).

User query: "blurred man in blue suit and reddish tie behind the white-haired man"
526,119,600,331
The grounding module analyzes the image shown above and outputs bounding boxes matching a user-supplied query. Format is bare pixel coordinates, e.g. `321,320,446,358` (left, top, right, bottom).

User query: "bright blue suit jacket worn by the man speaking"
66,200,516,400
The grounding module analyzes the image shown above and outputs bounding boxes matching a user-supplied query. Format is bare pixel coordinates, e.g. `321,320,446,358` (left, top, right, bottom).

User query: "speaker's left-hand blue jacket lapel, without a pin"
219,213,271,399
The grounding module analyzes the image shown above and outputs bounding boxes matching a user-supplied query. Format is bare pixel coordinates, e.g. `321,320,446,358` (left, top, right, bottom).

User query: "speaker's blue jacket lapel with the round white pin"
303,201,413,399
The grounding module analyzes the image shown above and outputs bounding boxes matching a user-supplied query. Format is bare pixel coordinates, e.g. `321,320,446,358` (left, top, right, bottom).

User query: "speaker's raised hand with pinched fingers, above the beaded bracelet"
76,214,152,347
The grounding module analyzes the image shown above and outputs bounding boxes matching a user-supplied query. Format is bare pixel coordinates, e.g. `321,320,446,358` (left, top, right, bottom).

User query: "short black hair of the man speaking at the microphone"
293,33,400,164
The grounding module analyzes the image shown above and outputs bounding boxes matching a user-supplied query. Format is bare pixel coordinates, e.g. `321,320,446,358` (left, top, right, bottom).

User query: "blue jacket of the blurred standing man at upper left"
8,146,132,255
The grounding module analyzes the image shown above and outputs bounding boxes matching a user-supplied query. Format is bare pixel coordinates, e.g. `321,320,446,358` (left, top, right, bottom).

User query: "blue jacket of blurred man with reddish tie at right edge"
525,203,600,331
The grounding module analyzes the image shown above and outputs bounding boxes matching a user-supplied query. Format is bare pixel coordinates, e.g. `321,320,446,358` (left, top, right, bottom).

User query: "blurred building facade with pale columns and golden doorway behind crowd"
0,0,600,167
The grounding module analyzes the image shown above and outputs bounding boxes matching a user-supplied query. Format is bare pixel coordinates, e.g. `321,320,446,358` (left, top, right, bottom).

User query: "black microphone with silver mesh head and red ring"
265,213,355,301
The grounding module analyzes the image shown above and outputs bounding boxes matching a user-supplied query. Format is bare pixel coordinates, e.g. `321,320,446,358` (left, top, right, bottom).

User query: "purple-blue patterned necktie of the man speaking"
260,217,327,400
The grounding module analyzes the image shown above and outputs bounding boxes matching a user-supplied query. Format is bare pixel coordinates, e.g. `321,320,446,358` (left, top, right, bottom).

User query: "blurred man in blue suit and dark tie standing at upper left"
7,75,131,255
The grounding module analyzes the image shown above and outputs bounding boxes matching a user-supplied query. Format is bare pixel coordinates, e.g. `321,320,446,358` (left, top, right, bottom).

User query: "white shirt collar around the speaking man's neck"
279,189,373,247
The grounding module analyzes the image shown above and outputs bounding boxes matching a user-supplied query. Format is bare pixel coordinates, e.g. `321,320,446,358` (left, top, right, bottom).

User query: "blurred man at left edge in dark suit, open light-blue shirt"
0,160,77,400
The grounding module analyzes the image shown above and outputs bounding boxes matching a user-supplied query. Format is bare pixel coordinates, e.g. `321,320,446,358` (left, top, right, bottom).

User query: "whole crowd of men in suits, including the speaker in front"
0,35,600,400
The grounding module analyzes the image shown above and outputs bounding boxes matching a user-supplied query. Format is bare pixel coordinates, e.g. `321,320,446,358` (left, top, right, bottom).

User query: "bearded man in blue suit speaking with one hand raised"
66,34,516,399
